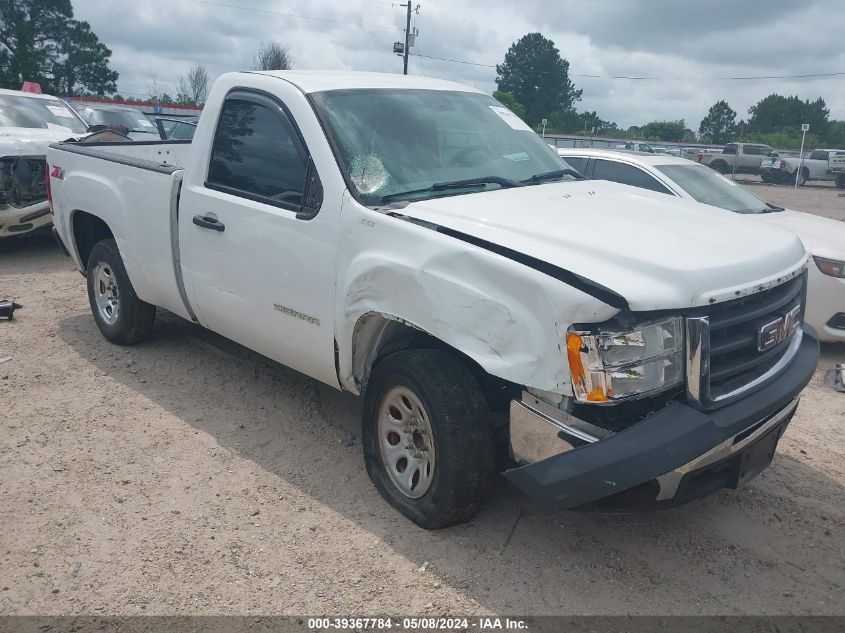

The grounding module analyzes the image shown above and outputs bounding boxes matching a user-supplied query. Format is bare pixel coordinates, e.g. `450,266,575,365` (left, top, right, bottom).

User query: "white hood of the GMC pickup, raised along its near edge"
397,181,807,310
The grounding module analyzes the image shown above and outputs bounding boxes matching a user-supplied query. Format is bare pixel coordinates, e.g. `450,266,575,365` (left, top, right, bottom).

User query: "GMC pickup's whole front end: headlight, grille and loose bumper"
505,275,818,510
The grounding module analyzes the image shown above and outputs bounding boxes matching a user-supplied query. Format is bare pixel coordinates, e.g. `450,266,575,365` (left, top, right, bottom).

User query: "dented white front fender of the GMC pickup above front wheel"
336,194,619,395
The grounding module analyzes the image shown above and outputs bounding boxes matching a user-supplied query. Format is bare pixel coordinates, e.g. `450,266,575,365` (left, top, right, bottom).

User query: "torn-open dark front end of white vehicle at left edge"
0,156,51,237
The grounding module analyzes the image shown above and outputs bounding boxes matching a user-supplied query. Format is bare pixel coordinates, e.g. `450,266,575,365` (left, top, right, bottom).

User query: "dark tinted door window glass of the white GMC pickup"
206,97,307,207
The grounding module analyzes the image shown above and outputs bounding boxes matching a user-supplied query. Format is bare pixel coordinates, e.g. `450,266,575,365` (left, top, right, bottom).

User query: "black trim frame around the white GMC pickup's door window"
203,87,322,220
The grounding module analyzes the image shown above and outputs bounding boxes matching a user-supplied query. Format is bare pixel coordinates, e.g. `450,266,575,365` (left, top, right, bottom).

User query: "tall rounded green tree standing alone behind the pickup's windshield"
496,33,581,126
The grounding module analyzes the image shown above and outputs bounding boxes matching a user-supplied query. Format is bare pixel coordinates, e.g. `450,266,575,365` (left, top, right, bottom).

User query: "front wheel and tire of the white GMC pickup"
362,349,496,530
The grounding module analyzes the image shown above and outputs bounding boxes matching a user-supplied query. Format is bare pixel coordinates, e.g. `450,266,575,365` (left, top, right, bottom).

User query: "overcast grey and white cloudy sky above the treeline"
74,0,845,128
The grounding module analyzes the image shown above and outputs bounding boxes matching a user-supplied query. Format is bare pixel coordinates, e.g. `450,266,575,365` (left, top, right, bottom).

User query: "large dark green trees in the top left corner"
0,0,117,94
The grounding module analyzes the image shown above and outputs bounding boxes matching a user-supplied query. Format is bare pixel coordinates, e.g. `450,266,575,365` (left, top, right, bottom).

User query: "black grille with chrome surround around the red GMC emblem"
687,273,806,408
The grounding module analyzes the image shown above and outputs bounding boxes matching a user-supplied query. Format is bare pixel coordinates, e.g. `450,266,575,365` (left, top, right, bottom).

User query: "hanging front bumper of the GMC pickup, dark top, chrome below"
504,328,819,510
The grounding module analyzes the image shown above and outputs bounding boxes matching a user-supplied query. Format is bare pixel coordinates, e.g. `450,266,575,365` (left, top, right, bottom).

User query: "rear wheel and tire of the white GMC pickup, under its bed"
86,238,156,345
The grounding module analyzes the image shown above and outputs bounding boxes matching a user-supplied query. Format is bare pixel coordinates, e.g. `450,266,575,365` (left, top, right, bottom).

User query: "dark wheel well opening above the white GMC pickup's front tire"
352,313,522,412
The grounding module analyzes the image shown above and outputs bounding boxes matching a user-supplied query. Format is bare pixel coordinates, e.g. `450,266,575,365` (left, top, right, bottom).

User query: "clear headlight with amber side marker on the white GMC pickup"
566,317,684,403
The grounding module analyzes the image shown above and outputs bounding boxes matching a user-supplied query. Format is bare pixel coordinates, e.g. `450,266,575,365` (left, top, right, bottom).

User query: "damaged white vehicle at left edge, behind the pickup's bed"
0,90,88,238
